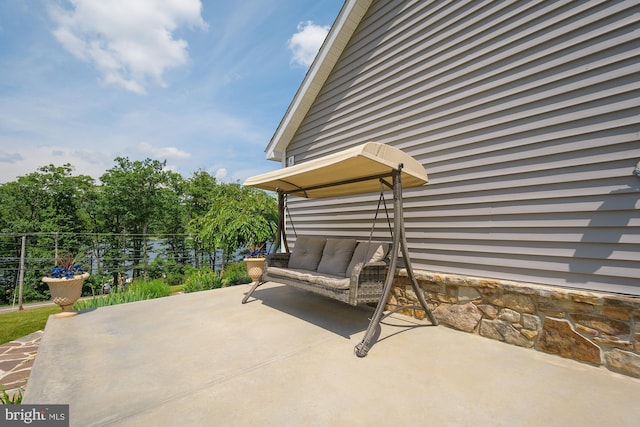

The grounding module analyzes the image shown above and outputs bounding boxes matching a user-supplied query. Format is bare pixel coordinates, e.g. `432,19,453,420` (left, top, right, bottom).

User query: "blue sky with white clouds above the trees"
0,0,343,183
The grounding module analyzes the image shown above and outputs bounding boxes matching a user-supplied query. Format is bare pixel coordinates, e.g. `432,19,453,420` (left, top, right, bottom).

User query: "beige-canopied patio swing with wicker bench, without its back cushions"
242,142,438,357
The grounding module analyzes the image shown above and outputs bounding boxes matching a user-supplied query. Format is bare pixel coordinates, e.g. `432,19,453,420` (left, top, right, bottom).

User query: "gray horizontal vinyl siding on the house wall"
286,1,640,295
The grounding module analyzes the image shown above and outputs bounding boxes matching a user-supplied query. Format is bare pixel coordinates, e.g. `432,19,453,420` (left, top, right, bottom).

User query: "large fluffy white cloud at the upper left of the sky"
52,0,207,94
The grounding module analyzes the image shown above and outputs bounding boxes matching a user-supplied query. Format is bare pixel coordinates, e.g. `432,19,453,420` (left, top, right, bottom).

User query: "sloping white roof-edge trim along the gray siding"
265,0,373,164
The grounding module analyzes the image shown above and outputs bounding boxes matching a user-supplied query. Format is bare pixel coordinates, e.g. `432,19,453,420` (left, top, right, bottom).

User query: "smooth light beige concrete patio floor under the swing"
24,283,640,426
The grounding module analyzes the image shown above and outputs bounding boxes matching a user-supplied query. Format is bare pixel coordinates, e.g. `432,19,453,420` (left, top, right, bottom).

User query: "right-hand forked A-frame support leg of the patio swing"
355,164,438,357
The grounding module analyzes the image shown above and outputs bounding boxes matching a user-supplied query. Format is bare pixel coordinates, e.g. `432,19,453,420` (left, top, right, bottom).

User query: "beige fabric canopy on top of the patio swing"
244,142,428,198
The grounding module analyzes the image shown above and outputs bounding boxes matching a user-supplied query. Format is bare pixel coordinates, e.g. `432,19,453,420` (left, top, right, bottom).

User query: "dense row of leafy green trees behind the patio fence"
0,157,277,301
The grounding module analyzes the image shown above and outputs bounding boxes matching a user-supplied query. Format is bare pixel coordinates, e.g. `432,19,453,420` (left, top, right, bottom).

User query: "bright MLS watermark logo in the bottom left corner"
0,405,69,427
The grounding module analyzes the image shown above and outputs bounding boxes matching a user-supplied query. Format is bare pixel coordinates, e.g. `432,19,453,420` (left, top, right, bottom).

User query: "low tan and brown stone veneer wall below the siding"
390,270,640,378
